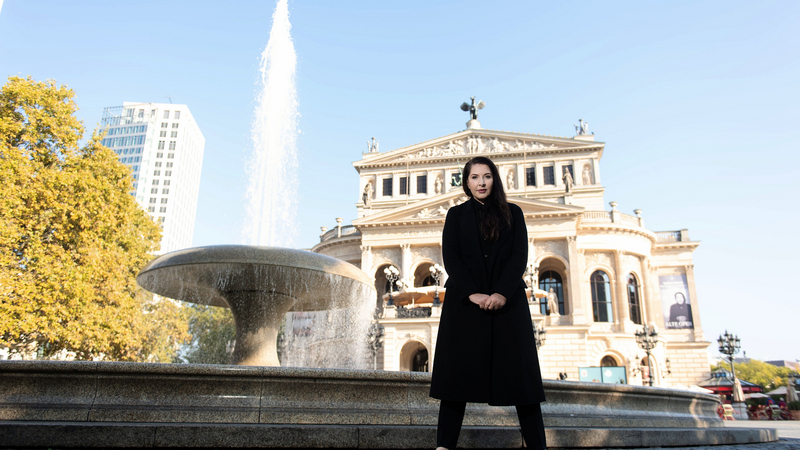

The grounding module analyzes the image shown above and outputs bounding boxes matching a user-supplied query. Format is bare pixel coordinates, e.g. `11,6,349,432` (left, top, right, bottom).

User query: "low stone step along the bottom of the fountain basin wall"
0,421,778,449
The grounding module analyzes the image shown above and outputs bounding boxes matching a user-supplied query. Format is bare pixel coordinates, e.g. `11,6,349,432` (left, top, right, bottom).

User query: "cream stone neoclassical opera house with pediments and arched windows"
312,120,710,386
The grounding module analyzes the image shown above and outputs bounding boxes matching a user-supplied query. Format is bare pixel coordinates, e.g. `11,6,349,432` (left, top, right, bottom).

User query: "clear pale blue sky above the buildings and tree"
0,0,800,360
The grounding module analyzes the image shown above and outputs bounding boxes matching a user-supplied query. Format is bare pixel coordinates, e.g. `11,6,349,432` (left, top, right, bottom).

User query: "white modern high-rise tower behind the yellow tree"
102,102,205,254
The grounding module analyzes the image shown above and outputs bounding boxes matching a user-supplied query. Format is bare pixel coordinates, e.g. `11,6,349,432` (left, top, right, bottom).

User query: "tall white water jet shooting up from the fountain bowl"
244,0,298,247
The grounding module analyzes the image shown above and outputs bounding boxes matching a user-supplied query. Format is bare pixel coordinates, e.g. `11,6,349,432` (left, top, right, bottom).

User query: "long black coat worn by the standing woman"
431,200,544,405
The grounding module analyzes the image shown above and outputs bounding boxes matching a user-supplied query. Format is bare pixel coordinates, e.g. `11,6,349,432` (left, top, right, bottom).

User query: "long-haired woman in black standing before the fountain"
431,157,546,449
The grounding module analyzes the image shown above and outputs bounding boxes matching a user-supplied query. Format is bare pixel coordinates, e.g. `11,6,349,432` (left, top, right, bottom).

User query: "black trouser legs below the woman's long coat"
436,400,547,450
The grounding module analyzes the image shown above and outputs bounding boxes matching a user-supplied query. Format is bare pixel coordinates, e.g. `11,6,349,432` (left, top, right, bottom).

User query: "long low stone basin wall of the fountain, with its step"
0,361,778,448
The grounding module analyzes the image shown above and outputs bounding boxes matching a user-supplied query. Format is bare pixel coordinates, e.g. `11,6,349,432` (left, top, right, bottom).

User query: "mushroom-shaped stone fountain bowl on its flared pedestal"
136,245,376,366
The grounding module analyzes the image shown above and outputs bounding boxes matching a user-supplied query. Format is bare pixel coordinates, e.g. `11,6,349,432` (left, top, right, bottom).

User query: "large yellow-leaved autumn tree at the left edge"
0,77,188,361
